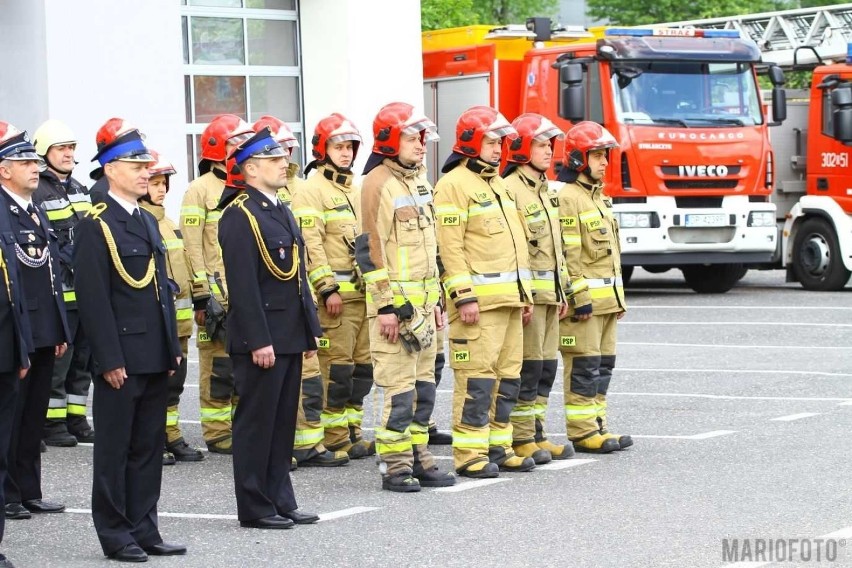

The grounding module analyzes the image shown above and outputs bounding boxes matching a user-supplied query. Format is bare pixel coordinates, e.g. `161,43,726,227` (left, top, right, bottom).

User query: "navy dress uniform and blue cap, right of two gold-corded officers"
219,129,322,528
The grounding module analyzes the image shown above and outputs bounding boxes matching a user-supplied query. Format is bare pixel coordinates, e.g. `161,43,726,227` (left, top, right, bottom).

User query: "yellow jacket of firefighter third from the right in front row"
435,159,533,321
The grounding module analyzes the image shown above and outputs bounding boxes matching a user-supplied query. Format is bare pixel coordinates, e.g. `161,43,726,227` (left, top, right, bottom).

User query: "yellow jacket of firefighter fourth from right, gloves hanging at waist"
356,158,440,317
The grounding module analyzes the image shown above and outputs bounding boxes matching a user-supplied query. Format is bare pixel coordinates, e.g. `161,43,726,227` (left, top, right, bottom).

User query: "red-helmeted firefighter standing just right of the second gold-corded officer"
293,113,376,459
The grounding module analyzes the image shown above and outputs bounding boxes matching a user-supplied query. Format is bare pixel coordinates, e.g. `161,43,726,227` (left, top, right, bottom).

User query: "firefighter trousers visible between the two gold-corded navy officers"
196,329,237,444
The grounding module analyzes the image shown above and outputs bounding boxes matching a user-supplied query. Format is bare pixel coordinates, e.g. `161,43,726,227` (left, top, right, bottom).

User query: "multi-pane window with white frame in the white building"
181,0,304,179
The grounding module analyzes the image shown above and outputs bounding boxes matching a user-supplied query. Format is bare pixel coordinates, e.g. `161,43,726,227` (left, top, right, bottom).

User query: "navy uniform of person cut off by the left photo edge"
0,135,32,566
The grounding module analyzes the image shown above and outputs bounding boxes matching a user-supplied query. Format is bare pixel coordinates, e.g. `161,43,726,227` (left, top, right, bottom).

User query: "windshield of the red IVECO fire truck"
612,61,763,128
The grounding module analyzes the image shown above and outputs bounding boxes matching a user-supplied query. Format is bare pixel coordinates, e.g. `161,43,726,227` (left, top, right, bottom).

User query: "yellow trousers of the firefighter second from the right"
512,304,559,444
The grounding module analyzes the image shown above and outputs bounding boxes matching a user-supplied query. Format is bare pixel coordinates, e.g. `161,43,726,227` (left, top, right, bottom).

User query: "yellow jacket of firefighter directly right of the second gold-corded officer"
292,164,364,302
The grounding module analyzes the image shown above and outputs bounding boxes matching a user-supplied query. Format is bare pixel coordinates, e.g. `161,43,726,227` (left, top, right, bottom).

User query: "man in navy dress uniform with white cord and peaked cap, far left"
0,123,69,519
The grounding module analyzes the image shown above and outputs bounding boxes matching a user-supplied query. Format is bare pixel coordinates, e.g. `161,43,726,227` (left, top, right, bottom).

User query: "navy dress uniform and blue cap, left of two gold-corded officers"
74,123,186,561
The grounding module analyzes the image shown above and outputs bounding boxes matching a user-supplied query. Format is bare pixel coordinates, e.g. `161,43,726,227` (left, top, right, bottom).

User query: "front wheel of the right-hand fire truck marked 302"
793,217,850,292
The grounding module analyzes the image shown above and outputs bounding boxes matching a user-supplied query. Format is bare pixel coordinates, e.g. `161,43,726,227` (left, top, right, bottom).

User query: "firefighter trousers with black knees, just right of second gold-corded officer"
318,301,373,450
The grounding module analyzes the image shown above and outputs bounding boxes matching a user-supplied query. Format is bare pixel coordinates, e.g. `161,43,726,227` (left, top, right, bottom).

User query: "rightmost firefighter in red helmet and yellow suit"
559,121,633,453
